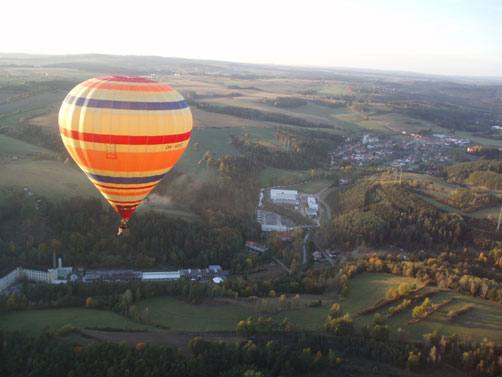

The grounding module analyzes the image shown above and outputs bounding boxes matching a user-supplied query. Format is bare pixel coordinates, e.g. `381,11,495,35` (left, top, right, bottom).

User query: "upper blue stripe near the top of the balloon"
65,96,188,110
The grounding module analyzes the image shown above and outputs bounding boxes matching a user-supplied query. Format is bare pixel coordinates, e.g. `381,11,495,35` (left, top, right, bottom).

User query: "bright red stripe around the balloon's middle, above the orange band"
60,128,192,145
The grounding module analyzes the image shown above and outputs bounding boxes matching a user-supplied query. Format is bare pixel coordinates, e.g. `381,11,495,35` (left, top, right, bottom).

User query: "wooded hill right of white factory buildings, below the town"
328,182,469,248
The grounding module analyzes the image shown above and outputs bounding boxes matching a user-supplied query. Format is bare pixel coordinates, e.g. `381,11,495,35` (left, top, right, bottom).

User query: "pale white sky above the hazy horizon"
0,0,502,77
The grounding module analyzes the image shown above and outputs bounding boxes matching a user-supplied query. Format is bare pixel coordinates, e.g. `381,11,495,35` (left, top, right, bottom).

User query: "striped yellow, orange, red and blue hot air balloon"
59,76,192,235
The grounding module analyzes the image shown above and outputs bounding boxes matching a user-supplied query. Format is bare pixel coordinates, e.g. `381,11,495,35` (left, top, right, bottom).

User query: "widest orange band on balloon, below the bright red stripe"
67,147,185,172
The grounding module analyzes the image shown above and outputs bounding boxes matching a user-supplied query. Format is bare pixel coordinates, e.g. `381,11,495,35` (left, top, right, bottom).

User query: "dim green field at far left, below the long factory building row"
0,308,148,335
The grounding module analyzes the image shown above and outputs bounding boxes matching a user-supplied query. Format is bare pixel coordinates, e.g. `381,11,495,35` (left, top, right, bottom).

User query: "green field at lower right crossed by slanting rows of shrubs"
341,273,502,343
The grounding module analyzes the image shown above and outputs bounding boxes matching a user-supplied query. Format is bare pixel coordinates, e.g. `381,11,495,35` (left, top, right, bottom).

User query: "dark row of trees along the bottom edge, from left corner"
0,333,337,377
